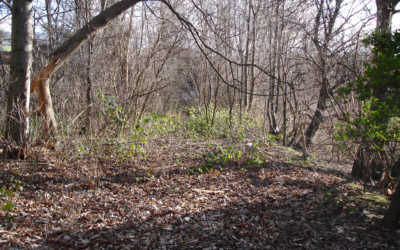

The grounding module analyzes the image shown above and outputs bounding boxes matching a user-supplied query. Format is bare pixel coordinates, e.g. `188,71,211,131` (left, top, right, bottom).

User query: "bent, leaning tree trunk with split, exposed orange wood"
30,0,145,139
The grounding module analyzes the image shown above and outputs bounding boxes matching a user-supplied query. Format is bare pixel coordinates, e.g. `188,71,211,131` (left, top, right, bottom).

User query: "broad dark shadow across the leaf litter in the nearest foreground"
0,173,400,249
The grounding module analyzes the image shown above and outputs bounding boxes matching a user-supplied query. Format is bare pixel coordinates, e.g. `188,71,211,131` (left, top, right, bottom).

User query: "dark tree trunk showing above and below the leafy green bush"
351,0,400,182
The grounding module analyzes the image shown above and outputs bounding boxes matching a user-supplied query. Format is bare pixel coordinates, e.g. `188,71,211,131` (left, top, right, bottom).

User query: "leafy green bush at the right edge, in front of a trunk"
335,32,400,151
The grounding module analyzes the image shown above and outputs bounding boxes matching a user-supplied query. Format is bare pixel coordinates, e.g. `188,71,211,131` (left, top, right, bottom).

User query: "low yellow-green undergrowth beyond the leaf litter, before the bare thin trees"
69,106,262,164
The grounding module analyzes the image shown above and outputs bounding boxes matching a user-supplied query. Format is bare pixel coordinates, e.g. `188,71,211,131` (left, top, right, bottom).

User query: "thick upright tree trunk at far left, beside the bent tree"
6,0,33,157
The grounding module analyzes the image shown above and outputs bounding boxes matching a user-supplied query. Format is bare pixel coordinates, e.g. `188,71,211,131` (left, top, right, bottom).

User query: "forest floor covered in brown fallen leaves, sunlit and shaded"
0,137,400,249
